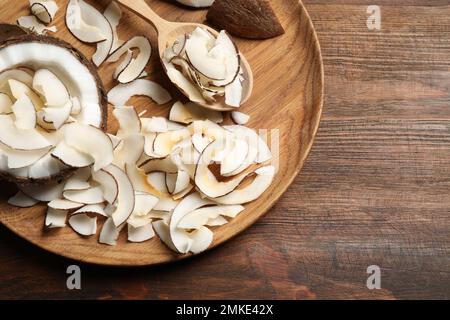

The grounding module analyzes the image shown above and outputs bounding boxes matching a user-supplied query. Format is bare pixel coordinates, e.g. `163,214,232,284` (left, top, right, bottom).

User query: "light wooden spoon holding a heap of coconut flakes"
116,0,253,111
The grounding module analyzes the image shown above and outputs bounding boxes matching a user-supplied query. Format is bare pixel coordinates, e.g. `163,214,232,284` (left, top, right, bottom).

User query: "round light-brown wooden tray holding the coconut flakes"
0,0,323,266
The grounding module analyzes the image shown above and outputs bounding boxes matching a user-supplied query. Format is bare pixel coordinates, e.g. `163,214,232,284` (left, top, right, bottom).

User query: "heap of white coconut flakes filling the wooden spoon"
164,27,244,108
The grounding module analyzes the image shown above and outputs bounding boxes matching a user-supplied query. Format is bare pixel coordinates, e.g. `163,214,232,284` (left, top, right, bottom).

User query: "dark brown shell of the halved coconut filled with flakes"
0,24,108,186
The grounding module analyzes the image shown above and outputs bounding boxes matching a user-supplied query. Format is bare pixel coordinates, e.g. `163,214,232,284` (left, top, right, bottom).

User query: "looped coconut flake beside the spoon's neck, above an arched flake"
106,36,152,83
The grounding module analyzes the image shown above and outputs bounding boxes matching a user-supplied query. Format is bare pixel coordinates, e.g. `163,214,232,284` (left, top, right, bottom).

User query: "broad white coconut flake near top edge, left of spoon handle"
66,0,107,43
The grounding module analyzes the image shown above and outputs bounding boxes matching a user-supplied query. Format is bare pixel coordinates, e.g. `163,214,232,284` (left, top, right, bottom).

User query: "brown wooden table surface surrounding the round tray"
0,0,450,299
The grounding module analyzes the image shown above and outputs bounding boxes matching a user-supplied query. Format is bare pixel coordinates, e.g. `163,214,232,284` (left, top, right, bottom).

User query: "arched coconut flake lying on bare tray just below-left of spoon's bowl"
108,79,172,107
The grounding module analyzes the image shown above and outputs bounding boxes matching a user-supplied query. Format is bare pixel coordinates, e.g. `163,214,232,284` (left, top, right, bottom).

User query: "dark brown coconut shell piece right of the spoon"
207,0,284,39
